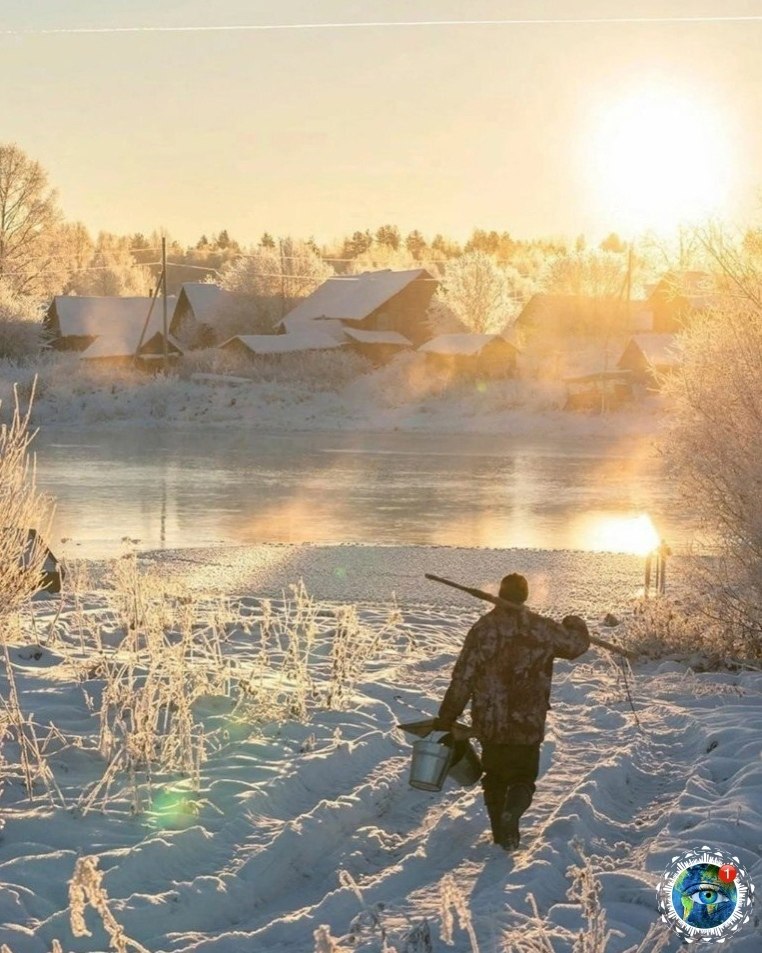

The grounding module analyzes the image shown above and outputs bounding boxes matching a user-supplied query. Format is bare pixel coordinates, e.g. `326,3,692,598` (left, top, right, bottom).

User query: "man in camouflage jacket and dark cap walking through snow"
435,573,590,850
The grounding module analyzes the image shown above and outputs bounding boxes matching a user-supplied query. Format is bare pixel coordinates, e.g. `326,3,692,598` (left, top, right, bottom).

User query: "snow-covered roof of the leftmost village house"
53,295,176,351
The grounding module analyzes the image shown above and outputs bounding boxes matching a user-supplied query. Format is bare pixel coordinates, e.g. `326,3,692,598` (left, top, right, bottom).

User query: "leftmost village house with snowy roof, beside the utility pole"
43,295,175,351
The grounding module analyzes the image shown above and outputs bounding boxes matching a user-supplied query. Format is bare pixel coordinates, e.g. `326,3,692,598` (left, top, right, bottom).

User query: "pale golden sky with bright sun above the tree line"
0,0,762,243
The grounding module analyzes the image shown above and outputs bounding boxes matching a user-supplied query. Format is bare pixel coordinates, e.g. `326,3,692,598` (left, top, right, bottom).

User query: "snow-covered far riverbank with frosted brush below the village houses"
0,354,664,437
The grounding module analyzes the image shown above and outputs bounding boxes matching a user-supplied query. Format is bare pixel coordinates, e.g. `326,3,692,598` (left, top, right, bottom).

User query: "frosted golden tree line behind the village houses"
0,138,753,331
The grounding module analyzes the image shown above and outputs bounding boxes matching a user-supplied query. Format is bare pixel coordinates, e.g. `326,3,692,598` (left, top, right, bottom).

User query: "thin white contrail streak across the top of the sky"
0,14,762,36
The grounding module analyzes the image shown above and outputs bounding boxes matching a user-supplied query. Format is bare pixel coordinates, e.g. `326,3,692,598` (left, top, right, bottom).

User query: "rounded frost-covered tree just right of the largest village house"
429,252,524,334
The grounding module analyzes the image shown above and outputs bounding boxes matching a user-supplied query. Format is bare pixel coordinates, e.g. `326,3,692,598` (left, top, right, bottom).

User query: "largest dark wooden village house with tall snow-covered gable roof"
280,268,438,344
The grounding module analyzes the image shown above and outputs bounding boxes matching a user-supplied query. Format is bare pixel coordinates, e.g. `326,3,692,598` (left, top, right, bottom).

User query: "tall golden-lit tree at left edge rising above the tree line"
0,143,70,297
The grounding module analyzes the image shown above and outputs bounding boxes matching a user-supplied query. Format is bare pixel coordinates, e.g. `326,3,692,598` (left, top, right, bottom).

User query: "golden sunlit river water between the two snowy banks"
36,427,689,556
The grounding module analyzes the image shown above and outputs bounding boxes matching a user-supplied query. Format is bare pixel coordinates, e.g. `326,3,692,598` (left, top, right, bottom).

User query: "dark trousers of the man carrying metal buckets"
482,741,540,843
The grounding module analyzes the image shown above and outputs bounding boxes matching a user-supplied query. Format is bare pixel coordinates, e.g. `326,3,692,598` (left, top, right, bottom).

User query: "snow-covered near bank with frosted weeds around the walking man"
0,546,762,953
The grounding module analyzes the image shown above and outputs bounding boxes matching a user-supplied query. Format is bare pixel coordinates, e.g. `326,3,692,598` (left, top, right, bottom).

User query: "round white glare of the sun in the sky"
588,86,732,232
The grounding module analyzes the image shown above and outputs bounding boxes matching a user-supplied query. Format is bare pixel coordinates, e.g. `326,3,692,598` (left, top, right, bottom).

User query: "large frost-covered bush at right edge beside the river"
664,233,762,657
